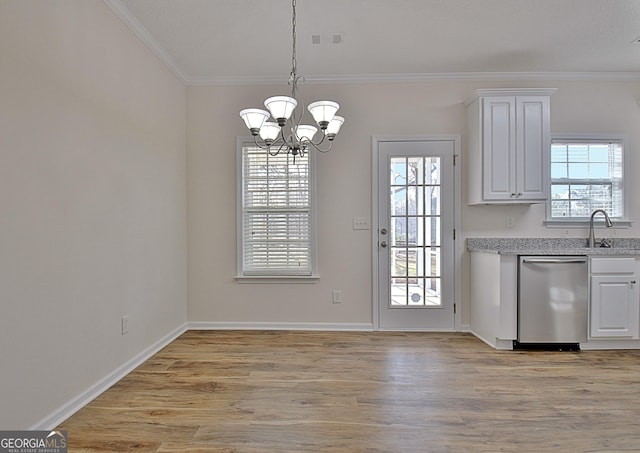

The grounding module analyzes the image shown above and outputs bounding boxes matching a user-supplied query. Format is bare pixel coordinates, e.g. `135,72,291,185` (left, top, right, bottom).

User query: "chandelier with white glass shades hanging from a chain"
240,0,344,162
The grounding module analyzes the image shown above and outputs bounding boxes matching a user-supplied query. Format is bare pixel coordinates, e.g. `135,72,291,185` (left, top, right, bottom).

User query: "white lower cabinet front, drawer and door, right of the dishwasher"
589,257,640,339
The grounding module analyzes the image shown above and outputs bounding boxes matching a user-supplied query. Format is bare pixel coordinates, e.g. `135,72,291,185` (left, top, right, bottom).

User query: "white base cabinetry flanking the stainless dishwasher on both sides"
470,252,640,349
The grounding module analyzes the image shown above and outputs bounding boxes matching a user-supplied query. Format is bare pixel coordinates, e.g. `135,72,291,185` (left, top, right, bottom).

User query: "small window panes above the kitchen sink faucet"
547,136,628,223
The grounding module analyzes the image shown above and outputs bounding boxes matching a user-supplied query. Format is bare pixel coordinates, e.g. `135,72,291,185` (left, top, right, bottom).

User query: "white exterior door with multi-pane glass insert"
374,139,457,330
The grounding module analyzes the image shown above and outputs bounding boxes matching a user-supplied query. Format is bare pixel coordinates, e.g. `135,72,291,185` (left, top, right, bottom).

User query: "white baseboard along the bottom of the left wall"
29,323,187,431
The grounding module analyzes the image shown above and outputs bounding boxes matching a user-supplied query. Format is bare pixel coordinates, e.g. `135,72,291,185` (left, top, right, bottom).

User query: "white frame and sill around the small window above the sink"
544,133,632,228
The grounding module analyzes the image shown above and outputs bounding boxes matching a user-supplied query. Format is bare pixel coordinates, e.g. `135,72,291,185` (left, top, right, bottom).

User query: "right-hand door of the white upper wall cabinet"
515,96,551,200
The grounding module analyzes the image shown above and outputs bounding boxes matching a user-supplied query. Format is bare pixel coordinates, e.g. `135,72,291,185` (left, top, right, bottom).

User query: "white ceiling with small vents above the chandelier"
104,0,640,85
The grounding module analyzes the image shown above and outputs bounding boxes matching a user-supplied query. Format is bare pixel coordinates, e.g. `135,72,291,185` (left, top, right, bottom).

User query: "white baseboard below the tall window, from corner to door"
187,322,373,332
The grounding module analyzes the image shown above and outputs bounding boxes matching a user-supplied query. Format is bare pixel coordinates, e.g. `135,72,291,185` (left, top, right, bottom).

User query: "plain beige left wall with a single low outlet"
0,0,186,429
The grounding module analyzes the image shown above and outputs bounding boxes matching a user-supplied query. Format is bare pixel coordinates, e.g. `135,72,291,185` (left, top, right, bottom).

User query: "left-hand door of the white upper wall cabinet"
482,96,516,201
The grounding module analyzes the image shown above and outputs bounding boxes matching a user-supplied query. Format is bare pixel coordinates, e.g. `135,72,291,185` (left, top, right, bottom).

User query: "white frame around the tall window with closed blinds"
235,137,320,283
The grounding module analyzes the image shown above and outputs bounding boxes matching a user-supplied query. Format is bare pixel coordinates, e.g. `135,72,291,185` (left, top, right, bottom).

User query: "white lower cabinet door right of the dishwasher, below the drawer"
590,276,639,338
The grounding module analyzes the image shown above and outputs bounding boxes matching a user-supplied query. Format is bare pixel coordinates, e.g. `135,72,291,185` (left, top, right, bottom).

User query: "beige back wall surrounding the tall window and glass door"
187,81,640,325
